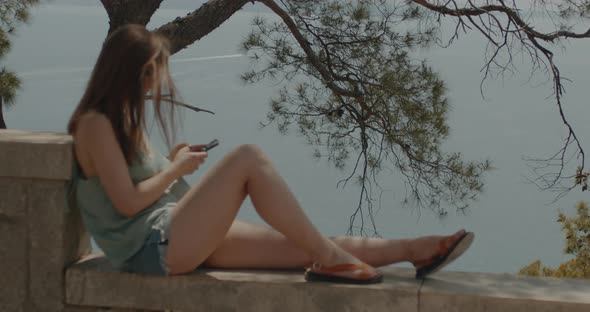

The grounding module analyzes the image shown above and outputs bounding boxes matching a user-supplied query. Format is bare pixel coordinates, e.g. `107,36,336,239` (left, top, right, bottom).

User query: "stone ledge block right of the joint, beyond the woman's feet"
420,272,590,312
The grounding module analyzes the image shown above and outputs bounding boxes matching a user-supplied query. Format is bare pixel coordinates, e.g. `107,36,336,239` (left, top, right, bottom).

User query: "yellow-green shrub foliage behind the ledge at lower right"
519,202,590,279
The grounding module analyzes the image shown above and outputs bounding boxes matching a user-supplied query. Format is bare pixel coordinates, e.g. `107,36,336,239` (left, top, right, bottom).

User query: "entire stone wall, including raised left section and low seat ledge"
0,130,590,312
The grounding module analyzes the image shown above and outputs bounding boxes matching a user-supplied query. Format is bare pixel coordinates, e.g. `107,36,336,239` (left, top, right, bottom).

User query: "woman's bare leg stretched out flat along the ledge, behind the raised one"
205,220,464,269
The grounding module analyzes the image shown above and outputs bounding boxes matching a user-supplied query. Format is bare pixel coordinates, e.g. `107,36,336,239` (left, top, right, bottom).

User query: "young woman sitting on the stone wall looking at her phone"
68,25,473,283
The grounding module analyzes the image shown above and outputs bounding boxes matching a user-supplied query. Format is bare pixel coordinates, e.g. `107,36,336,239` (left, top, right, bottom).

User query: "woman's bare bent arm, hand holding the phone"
75,113,207,217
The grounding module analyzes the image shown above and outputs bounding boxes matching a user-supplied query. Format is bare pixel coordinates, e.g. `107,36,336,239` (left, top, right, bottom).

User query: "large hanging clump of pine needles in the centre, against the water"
242,0,498,232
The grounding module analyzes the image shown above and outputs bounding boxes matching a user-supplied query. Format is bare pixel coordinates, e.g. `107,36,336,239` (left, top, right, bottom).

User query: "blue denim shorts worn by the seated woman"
125,212,170,276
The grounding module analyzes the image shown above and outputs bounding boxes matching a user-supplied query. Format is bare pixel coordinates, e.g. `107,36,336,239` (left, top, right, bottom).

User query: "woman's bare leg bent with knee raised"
167,145,372,274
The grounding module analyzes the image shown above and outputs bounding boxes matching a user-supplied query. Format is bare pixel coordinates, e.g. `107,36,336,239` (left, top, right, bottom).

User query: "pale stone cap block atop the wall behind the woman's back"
0,130,73,180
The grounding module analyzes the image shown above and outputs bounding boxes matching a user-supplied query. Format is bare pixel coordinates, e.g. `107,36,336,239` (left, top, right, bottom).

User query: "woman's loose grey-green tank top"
70,152,189,269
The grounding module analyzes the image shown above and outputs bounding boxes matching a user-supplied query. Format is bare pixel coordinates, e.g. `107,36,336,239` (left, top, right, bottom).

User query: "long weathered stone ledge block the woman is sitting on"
66,258,420,312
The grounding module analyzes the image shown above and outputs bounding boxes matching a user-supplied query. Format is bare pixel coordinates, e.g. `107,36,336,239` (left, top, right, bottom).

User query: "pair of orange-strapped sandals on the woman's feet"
305,230,474,284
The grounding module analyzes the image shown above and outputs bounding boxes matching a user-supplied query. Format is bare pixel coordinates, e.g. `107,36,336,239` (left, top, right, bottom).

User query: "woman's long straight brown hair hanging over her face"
68,25,176,164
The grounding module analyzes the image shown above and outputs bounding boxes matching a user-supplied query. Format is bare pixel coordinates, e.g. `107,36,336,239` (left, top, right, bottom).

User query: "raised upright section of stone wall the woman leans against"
0,130,88,312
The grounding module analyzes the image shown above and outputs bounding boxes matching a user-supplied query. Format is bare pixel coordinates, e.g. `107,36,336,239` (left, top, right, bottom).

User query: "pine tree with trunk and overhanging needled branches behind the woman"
101,0,590,235
